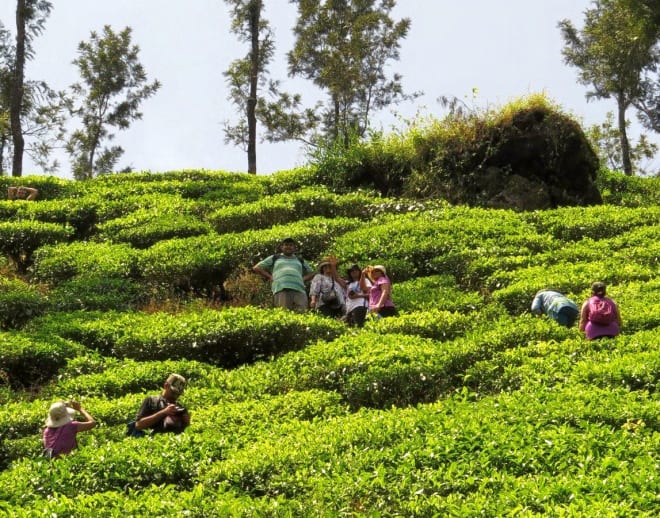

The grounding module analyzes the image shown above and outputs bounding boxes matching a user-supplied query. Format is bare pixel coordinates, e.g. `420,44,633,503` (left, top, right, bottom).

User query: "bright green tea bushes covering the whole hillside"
0,164,660,518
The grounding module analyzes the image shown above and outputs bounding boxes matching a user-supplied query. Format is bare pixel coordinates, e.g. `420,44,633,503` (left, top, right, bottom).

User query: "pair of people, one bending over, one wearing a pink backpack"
532,282,622,340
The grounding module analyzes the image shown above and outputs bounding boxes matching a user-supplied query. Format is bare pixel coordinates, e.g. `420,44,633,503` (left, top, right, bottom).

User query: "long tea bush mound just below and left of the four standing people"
27,308,345,367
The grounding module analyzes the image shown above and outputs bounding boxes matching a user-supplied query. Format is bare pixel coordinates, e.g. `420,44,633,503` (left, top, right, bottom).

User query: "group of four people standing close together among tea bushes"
253,238,397,327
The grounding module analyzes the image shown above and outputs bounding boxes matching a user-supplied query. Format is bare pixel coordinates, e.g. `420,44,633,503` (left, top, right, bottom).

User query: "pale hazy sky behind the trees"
0,0,644,178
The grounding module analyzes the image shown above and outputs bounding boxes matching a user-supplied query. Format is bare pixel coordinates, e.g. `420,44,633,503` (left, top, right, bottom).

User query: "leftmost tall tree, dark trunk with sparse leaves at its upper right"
9,0,53,176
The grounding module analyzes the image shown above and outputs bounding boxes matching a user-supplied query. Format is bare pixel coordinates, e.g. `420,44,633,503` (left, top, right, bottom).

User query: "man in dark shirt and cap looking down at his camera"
128,374,190,436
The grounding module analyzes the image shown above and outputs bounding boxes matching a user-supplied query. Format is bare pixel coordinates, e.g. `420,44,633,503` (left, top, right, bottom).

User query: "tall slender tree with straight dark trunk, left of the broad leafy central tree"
224,0,274,174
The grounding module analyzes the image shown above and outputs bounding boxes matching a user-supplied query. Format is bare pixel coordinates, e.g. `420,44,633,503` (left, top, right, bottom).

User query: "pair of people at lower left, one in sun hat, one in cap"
42,374,190,459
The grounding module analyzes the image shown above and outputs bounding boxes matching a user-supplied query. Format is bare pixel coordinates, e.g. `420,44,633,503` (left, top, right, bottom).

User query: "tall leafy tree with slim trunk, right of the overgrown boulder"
559,0,659,175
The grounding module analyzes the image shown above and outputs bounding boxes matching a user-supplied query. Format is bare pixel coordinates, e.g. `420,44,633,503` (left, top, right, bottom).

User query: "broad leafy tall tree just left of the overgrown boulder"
288,0,415,145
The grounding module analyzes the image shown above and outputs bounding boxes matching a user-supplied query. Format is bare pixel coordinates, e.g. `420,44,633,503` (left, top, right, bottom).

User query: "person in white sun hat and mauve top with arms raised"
43,401,96,459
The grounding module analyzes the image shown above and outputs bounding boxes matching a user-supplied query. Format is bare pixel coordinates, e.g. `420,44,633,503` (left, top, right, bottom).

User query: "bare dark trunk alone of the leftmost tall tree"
9,0,26,176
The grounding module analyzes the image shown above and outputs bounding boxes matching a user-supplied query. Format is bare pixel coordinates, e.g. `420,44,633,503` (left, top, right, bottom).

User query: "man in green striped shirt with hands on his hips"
252,237,315,313
